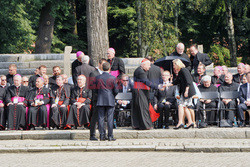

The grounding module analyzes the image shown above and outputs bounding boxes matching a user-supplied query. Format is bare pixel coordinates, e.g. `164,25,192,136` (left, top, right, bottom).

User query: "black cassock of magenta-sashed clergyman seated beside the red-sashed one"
27,88,50,127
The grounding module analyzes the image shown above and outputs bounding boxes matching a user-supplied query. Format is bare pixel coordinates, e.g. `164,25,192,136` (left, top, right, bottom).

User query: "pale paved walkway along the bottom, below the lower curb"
0,152,250,167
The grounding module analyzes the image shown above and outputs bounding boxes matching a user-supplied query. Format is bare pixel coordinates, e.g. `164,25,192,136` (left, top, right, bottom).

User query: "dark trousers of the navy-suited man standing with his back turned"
98,106,115,138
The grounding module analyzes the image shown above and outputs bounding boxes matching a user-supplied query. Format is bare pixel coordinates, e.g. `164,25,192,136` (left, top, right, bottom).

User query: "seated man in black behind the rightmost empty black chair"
218,72,239,122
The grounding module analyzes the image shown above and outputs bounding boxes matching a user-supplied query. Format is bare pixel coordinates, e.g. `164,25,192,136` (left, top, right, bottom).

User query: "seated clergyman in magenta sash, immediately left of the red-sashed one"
27,77,50,130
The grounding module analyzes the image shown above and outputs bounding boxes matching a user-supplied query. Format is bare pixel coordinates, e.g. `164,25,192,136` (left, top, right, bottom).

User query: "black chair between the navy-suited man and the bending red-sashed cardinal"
115,92,132,126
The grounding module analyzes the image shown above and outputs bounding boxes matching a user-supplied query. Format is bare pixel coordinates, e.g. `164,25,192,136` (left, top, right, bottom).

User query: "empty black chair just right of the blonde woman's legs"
200,92,220,123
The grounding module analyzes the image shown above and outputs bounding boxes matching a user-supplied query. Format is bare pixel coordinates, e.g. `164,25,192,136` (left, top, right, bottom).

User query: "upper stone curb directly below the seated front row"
0,128,250,140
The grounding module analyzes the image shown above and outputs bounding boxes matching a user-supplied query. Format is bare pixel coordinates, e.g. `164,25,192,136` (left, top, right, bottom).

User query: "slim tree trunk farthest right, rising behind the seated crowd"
225,0,237,67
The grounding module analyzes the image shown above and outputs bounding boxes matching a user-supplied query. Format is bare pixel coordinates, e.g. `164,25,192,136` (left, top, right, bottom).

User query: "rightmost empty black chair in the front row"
219,91,239,126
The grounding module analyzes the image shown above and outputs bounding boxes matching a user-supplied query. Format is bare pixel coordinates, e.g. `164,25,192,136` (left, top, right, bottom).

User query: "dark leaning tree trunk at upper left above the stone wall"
35,2,55,53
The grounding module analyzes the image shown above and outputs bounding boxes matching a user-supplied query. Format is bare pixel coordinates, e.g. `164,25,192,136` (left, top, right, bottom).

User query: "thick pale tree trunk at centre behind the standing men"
86,0,109,65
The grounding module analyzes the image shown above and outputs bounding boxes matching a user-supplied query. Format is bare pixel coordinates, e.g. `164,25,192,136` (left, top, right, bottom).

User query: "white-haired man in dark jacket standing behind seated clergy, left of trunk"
72,55,95,86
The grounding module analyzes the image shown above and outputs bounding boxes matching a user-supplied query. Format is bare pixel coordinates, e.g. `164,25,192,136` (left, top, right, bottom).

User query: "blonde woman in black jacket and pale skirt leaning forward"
173,59,195,129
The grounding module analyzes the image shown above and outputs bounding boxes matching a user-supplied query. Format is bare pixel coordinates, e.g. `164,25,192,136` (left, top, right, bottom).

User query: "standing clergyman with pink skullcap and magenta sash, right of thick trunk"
107,48,125,78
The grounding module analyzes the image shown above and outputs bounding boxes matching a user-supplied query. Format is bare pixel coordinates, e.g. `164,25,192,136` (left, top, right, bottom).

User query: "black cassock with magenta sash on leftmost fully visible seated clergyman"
6,85,29,130
